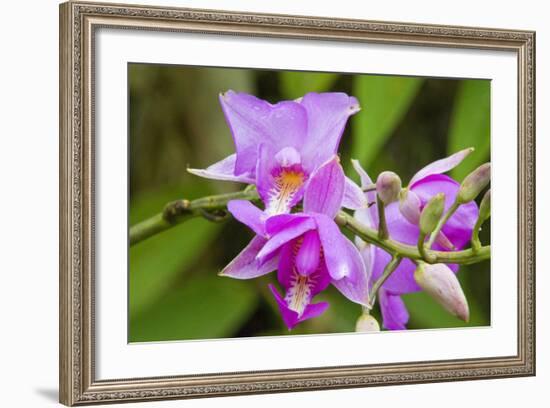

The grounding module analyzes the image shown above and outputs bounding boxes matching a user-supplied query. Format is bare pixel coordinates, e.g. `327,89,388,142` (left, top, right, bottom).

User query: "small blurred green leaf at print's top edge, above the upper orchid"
279,71,338,99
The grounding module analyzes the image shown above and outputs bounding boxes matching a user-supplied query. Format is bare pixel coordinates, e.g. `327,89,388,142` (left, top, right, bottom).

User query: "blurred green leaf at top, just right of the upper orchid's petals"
352,75,423,167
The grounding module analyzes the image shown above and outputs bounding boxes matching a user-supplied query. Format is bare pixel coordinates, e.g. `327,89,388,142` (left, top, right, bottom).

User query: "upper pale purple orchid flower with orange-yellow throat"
189,91,363,215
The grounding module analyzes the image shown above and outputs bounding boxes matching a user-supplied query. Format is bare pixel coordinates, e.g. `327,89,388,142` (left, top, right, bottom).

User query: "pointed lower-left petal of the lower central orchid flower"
219,235,279,279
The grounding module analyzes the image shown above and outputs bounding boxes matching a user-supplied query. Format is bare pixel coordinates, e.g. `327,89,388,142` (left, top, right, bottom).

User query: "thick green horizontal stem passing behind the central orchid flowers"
129,189,491,264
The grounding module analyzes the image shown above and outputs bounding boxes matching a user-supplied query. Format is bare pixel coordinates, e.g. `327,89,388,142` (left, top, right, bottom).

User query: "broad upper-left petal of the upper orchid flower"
220,91,308,175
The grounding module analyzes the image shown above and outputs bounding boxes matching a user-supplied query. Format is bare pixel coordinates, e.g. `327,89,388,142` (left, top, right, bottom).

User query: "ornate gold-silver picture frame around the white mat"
59,2,535,405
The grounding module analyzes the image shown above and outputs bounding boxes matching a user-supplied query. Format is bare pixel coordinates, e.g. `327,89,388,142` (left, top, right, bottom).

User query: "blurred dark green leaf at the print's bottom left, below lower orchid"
129,271,258,342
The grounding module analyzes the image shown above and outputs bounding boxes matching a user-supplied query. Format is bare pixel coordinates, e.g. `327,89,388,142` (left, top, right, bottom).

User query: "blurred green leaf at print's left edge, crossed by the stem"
128,188,221,319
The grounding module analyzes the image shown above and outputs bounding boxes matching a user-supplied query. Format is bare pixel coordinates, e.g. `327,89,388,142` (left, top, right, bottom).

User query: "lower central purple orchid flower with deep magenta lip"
220,156,369,330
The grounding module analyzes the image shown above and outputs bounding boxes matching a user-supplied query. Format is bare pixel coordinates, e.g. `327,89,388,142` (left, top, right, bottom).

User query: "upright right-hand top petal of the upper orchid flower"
299,92,360,172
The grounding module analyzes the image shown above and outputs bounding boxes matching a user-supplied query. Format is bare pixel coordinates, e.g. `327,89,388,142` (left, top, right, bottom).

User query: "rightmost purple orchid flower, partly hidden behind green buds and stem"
353,149,478,330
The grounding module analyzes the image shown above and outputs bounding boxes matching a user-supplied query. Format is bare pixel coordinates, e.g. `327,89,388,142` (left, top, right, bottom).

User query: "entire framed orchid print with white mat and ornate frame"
60,2,535,405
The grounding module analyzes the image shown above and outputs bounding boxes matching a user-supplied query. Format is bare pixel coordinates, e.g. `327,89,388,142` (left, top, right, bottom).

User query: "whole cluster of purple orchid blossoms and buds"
189,91,490,331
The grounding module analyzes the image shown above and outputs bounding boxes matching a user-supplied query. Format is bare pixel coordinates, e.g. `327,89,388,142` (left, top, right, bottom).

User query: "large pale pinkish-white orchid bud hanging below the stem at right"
414,264,470,322
